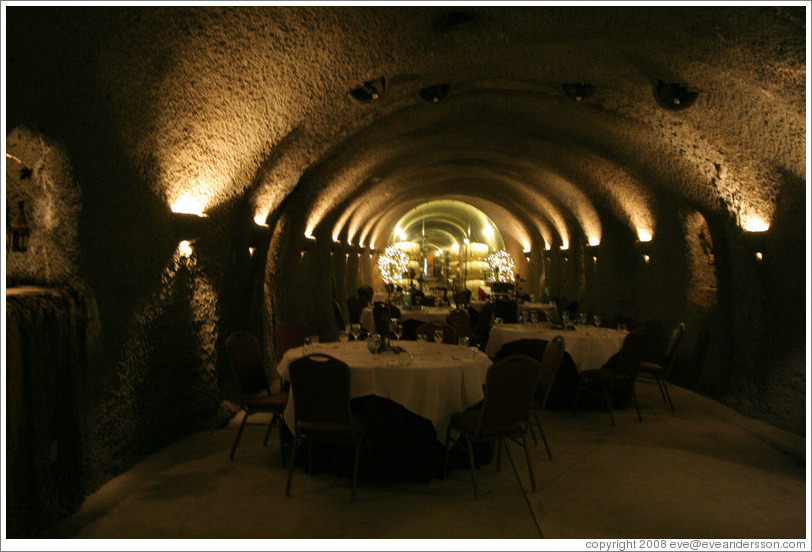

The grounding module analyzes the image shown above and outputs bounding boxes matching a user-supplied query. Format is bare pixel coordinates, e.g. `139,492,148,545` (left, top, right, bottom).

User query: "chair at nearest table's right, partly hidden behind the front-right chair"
496,335,564,460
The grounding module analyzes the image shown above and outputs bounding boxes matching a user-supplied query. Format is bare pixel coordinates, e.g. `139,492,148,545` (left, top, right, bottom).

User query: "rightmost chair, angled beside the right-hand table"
572,329,648,426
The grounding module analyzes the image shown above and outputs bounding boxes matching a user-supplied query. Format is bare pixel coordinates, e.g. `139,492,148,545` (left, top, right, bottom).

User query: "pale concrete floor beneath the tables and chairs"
47,384,808,547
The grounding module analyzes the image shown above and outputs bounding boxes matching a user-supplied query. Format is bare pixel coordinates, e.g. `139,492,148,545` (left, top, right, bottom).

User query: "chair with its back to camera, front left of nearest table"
285,354,367,500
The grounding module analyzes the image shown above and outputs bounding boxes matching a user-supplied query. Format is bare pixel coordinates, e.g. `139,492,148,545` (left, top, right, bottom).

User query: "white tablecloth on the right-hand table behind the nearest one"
485,324,628,371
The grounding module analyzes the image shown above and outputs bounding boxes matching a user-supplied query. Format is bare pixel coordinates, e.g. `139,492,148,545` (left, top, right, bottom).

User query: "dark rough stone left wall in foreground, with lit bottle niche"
6,25,241,537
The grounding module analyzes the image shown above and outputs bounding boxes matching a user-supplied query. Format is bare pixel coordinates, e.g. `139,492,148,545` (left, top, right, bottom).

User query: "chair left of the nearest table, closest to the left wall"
226,330,288,466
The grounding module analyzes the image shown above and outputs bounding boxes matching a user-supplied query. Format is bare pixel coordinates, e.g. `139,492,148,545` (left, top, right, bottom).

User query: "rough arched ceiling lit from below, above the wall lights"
10,5,808,247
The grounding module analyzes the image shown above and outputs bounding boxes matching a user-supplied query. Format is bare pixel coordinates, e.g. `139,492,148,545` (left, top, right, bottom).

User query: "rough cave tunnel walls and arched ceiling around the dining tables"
3,5,809,536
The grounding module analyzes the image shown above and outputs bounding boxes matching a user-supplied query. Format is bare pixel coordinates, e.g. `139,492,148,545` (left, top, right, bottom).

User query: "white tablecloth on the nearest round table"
277,341,492,441
